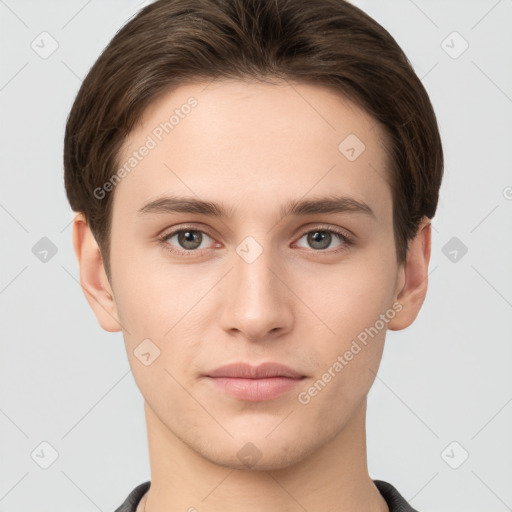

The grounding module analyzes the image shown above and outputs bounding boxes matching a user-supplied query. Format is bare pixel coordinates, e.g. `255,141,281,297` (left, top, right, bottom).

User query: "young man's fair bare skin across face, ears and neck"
73,80,430,512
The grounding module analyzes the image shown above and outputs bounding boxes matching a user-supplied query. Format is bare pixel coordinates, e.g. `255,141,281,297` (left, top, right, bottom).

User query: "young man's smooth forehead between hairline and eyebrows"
114,80,391,222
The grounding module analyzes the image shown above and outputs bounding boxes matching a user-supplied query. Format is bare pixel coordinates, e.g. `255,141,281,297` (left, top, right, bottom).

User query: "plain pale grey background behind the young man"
0,0,512,512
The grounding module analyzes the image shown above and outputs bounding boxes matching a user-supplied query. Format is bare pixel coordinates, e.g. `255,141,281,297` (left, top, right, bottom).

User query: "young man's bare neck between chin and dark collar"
141,399,389,512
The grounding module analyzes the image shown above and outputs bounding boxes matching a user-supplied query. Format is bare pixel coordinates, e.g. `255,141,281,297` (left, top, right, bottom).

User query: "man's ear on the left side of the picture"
73,213,121,332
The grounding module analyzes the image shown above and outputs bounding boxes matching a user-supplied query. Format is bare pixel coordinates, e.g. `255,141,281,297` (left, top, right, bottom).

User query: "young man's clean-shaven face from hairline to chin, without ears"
96,80,402,469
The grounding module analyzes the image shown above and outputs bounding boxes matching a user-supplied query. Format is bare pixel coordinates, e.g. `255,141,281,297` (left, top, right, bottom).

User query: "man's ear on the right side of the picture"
388,217,431,331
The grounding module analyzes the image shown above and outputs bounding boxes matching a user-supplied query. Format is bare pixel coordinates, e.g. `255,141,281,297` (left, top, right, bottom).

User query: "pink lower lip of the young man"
208,377,303,402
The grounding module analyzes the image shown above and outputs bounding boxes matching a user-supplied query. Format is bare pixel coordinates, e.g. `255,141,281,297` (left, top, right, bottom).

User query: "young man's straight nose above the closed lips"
220,240,294,342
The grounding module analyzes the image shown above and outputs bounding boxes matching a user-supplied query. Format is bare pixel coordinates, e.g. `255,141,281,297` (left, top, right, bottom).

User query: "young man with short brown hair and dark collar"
64,0,443,512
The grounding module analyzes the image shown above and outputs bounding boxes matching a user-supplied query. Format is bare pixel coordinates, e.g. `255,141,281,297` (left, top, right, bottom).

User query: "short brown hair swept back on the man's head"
64,0,444,279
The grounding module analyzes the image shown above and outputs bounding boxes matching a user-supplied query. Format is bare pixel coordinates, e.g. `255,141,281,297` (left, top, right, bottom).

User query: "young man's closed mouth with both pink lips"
206,362,306,402
